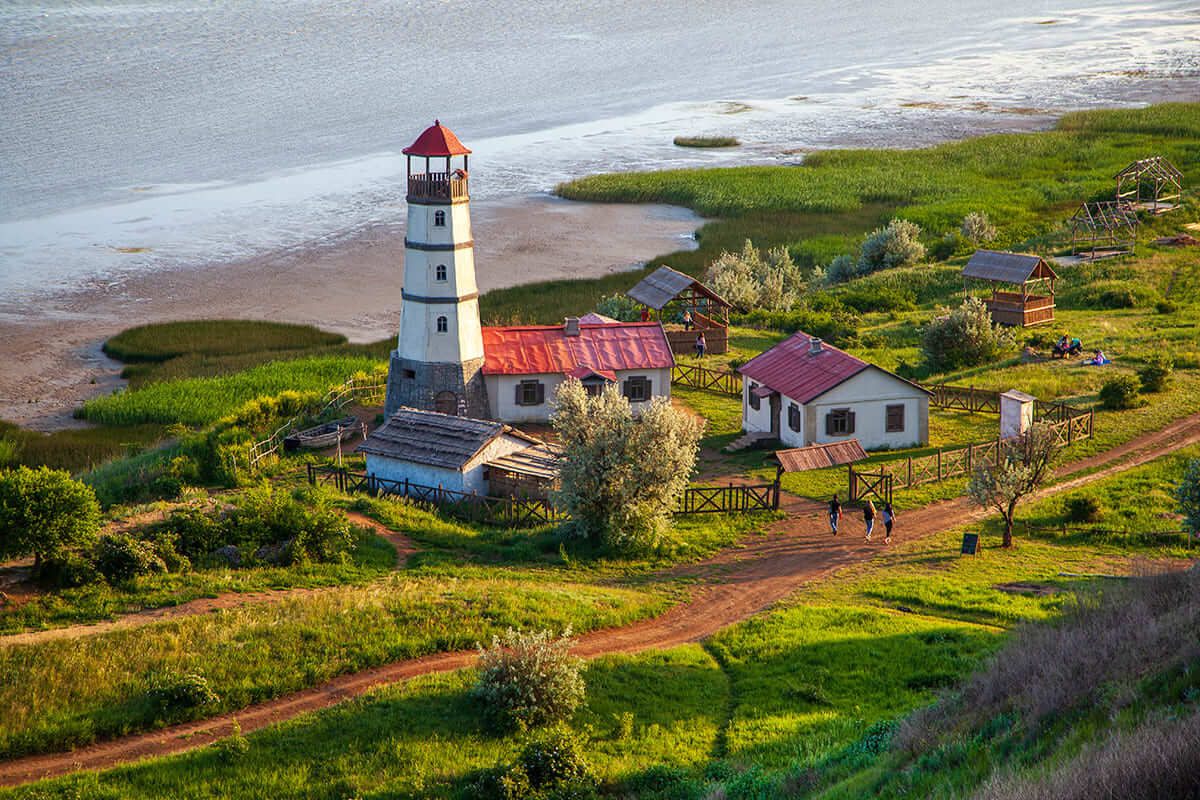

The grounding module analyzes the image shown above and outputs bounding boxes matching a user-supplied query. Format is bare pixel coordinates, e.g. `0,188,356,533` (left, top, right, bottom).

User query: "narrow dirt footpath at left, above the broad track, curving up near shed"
0,512,416,648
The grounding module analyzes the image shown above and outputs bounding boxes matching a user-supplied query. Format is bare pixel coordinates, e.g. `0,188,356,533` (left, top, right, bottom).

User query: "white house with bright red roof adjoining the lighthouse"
481,318,674,422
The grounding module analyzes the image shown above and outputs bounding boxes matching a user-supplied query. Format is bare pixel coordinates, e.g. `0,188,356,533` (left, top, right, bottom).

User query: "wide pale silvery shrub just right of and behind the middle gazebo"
704,239,808,312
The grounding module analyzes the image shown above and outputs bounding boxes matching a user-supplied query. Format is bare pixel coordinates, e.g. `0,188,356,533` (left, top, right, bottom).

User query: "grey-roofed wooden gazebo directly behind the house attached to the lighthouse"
625,266,730,355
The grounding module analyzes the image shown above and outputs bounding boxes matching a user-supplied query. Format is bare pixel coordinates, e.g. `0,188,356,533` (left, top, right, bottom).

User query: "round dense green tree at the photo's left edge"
0,467,100,570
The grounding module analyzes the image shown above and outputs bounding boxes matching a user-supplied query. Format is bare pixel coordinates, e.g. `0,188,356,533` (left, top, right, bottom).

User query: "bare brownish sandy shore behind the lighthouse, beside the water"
0,197,702,431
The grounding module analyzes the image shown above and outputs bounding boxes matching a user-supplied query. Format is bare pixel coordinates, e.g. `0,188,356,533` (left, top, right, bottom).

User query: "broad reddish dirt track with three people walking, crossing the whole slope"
0,414,1200,786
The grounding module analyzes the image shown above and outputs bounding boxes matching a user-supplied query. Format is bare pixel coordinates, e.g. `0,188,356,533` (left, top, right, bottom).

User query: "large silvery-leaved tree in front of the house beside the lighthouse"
551,379,701,551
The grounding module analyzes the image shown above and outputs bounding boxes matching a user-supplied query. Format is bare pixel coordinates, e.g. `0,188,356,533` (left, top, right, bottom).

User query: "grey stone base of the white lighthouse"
384,350,492,420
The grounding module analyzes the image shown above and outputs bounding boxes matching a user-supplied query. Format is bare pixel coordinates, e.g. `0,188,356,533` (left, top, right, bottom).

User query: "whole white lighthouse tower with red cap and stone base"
384,121,491,417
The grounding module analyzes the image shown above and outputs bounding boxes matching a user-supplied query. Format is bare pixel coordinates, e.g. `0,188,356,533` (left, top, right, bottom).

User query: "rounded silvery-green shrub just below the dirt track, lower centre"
472,626,584,730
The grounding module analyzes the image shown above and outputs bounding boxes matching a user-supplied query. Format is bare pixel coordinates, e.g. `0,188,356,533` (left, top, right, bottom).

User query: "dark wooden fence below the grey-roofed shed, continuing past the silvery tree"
307,464,779,528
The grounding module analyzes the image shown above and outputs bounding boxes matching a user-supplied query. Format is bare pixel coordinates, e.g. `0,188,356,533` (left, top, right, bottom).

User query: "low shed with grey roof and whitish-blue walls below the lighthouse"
358,408,550,495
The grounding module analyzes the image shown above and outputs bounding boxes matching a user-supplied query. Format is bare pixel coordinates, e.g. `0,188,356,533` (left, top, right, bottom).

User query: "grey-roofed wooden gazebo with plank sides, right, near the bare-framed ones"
962,249,1058,327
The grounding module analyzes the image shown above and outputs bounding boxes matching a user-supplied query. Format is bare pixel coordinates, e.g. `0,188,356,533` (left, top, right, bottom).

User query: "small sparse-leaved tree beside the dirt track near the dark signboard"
967,422,1058,547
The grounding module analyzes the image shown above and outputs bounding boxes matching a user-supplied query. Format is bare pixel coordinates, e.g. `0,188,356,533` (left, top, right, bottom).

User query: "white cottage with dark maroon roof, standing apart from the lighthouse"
738,331,930,450
